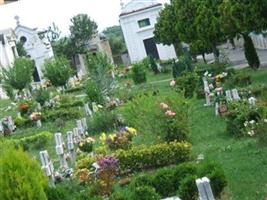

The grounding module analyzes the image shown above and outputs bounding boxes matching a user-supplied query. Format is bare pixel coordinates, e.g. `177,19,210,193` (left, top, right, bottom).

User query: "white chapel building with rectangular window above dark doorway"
119,0,176,63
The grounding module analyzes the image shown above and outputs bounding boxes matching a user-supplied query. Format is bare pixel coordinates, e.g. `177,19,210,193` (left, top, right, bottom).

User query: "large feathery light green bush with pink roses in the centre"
117,92,189,141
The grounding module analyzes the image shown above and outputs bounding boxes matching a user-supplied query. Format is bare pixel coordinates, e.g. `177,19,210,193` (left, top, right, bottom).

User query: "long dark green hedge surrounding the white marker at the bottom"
126,162,227,200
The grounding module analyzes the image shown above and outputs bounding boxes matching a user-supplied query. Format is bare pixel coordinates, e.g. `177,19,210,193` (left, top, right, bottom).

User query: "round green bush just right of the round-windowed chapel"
44,57,73,87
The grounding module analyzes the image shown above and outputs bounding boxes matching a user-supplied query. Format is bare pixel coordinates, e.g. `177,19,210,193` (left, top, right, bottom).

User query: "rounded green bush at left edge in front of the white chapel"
1,57,34,91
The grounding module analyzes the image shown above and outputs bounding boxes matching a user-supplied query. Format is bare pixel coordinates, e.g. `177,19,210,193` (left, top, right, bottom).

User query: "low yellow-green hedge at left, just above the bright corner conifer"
11,131,53,150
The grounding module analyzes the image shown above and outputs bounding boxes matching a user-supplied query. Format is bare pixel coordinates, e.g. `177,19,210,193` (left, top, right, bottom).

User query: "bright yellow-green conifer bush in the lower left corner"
0,144,47,200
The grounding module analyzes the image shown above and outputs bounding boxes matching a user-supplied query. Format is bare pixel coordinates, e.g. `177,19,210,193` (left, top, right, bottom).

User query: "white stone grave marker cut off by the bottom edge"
196,177,215,200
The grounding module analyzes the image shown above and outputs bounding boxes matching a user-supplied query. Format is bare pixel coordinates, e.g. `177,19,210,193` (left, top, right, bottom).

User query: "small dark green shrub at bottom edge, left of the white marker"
130,186,161,200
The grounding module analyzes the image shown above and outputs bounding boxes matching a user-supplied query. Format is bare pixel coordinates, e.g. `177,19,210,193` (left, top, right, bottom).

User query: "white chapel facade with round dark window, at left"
15,24,54,82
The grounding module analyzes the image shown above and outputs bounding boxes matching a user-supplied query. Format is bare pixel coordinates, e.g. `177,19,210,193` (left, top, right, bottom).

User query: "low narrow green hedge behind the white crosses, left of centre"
43,108,81,121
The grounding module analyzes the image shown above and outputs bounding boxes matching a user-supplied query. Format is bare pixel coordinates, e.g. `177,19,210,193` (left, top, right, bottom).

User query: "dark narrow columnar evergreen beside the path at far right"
243,34,260,70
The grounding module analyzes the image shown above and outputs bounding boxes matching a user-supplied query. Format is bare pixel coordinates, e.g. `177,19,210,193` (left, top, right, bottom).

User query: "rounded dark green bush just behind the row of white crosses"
88,110,119,134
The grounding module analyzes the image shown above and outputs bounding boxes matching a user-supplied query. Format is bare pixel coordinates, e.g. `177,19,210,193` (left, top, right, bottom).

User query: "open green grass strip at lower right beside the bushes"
190,101,267,200
